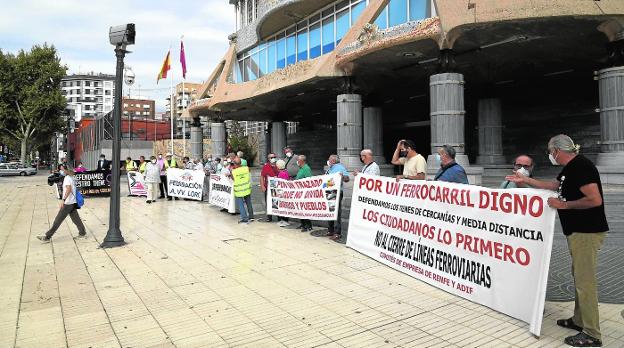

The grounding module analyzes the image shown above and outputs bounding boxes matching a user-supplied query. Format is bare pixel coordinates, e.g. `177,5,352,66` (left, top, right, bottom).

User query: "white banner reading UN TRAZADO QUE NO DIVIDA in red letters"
267,174,342,220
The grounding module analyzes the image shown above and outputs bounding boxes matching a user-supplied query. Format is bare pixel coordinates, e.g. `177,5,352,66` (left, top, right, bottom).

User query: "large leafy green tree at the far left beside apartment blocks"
0,44,67,163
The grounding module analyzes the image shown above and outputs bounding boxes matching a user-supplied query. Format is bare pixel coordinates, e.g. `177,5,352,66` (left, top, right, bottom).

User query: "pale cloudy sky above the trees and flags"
0,0,236,111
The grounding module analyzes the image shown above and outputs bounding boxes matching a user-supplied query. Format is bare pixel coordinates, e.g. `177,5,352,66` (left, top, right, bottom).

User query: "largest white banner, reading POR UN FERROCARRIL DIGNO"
347,174,556,336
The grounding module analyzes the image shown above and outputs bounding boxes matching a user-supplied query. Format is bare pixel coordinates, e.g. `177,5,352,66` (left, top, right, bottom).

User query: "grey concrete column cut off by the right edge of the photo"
596,66,624,184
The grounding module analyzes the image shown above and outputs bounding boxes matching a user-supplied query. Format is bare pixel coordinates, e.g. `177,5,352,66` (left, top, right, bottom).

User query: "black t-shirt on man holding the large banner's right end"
557,155,609,236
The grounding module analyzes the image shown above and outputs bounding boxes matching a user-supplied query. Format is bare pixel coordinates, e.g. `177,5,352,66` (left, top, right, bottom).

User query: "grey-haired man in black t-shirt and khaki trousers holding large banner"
506,134,609,347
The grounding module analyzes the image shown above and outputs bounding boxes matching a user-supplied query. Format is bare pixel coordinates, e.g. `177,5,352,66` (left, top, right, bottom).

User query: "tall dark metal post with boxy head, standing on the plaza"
100,23,135,248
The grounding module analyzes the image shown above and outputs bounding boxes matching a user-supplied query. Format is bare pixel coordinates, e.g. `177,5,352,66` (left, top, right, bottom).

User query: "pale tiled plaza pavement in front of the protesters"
0,174,624,347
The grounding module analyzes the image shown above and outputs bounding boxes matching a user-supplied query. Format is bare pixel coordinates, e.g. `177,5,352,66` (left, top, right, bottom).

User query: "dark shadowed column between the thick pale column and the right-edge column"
477,98,505,165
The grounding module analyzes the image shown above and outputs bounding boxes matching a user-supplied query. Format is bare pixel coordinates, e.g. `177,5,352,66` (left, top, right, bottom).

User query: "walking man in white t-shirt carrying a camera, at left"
37,165,87,243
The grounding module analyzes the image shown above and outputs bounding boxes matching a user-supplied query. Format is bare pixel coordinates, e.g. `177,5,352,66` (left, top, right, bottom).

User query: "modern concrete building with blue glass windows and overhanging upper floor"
189,0,624,184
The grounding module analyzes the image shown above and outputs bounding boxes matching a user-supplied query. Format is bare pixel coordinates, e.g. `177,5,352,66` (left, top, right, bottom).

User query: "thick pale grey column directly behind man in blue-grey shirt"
427,73,483,185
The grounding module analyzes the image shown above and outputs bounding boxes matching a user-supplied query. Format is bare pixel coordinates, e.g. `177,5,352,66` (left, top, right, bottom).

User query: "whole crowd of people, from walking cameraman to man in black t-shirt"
38,134,609,347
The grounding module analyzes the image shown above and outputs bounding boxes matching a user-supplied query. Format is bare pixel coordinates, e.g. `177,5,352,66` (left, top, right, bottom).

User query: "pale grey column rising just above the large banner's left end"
336,94,362,170
